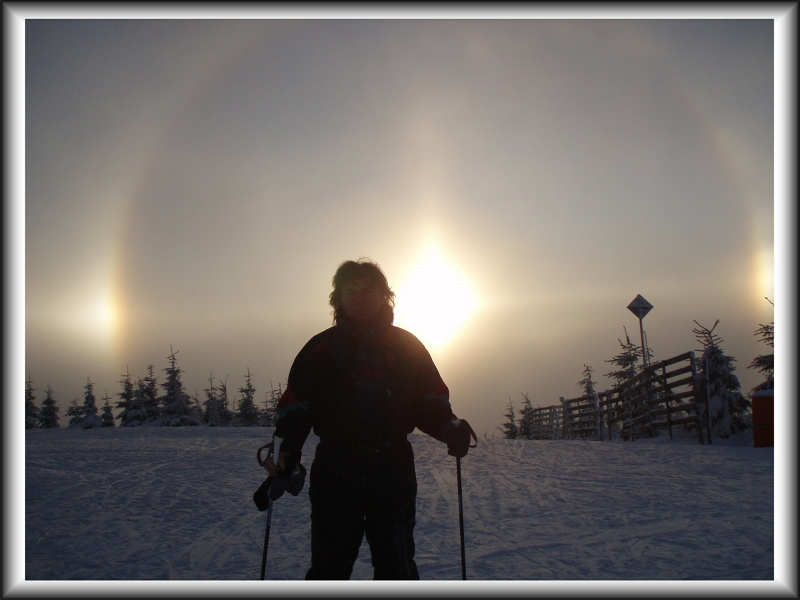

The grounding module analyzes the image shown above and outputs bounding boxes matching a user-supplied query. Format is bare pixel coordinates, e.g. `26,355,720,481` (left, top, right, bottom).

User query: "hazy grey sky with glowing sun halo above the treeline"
25,19,773,432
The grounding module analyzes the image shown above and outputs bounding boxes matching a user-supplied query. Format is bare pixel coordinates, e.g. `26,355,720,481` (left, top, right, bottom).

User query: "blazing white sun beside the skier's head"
395,249,478,348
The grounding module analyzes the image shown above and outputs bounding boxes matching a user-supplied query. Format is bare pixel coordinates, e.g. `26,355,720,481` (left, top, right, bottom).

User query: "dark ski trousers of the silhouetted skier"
306,440,419,579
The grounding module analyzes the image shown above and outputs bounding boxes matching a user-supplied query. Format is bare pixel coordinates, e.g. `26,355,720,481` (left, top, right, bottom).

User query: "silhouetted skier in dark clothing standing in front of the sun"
267,260,474,579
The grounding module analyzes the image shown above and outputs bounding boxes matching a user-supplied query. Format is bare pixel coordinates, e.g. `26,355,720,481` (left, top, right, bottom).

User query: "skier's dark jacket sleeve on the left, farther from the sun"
275,342,314,455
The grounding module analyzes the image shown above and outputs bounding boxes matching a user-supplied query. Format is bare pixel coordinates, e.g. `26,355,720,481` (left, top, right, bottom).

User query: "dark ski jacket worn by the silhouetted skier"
275,310,454,460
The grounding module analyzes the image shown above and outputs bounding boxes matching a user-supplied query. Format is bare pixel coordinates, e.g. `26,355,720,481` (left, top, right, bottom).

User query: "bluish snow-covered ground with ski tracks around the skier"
25,427,773,580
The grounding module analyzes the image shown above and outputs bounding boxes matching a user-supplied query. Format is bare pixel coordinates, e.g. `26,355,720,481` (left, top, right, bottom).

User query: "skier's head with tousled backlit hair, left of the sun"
330,258,394,323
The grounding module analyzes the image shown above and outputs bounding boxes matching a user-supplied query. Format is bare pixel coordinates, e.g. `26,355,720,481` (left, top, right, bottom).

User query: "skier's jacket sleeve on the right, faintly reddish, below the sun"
414,340,455,442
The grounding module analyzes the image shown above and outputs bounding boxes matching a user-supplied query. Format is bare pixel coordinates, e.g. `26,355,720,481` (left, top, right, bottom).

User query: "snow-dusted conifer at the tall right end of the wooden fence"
692,319,750,438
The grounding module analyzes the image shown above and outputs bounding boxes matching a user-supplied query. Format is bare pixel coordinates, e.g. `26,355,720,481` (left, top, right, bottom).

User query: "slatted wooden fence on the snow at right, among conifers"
531,352,711,444
